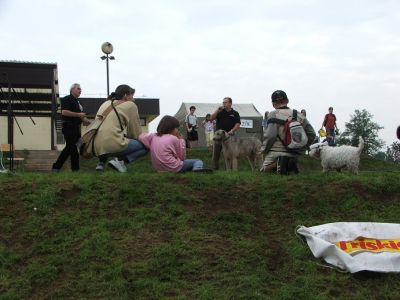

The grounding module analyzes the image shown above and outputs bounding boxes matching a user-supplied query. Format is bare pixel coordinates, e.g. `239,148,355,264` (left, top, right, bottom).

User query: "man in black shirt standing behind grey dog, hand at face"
210,97,240,170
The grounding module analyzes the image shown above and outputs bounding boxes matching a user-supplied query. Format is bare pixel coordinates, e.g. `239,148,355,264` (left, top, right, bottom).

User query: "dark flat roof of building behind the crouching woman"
79,97,160,116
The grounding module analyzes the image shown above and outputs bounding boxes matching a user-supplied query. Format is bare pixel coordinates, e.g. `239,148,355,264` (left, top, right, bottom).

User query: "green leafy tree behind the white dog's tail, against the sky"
337,109,385,156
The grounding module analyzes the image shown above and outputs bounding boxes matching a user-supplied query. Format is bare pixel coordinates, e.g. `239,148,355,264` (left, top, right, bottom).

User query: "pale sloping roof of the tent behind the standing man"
180,102,262,118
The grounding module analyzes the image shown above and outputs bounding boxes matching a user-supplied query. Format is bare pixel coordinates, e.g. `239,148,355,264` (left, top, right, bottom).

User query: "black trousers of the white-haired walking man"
53,125,81,171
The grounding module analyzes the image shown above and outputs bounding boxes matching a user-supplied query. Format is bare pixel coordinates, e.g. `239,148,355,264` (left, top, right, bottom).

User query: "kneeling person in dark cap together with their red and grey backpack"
261,90,316,174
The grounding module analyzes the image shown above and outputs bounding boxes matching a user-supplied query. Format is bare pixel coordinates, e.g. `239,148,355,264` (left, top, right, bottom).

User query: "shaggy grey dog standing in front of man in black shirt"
213,129,262,171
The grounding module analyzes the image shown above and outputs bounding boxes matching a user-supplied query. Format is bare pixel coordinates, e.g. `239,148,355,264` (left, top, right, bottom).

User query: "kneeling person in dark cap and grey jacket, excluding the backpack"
261,90,316,174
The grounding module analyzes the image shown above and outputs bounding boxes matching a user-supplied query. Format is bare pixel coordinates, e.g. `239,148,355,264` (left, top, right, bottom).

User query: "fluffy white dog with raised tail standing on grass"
309,137,364,174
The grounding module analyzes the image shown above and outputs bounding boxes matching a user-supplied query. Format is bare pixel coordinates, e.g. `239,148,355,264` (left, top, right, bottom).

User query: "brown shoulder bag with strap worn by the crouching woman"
77,102,123,159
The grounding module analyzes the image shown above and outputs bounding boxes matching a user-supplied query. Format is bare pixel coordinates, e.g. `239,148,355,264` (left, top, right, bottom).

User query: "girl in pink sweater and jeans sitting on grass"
139,116,211,173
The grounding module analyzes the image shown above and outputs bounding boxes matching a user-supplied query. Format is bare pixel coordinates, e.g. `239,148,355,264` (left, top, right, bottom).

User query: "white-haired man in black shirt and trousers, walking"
52,83,86,172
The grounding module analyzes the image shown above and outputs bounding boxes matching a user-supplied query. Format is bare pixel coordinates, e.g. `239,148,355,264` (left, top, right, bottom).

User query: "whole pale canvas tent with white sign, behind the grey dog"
175,102,263,147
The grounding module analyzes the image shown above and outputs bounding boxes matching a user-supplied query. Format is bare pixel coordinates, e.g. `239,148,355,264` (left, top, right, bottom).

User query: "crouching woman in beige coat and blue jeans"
94,84,148,173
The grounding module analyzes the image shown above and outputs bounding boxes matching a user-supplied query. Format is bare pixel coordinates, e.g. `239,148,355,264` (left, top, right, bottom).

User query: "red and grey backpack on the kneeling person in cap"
268,109,308,150
